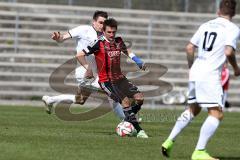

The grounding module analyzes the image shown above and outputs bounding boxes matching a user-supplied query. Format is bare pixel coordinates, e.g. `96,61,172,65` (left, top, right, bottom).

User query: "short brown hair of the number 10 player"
220,0,237,17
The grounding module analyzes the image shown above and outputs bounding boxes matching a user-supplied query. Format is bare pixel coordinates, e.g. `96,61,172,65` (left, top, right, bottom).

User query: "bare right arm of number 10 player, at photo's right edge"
224,46,240,76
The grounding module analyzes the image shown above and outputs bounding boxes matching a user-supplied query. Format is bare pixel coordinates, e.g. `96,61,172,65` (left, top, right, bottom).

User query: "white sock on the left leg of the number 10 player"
168,109,194,141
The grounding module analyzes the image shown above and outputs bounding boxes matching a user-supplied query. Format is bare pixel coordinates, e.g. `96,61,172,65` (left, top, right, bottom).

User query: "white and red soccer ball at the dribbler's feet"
116,121,137,137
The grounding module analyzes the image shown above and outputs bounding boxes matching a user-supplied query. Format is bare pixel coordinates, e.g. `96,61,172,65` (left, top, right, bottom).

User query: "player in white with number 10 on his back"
162,0,240,160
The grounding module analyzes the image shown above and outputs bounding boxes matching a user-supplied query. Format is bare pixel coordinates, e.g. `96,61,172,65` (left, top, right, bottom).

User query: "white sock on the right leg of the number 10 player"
196,116,220,150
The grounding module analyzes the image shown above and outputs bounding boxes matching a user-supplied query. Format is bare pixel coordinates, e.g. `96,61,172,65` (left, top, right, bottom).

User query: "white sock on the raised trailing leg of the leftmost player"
49,94,76,104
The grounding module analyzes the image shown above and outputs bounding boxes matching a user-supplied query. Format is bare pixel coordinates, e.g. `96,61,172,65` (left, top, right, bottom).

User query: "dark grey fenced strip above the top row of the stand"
0,0,240,13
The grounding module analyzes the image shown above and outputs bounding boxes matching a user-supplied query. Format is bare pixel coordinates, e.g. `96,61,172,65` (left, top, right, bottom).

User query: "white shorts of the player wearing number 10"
188,82,224,108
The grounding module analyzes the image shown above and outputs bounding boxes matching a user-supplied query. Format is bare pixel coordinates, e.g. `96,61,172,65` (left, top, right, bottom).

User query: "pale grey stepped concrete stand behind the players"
0,1,240,106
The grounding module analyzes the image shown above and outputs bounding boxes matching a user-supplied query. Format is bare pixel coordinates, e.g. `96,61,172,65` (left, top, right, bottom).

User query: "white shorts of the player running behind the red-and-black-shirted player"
75,66,101,89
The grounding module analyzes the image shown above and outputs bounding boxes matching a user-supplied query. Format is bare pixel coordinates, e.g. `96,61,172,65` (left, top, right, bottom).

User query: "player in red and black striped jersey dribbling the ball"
76,18,148,138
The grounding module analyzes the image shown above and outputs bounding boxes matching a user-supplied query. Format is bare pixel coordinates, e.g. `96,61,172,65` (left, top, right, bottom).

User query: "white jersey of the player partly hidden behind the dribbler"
68,25,98,76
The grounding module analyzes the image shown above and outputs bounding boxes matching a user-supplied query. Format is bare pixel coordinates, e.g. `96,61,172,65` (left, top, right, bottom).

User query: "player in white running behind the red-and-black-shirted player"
42,11,125,120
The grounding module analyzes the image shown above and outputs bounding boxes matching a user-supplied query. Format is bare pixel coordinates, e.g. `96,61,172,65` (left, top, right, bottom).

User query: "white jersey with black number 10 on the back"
189,17,240,81
